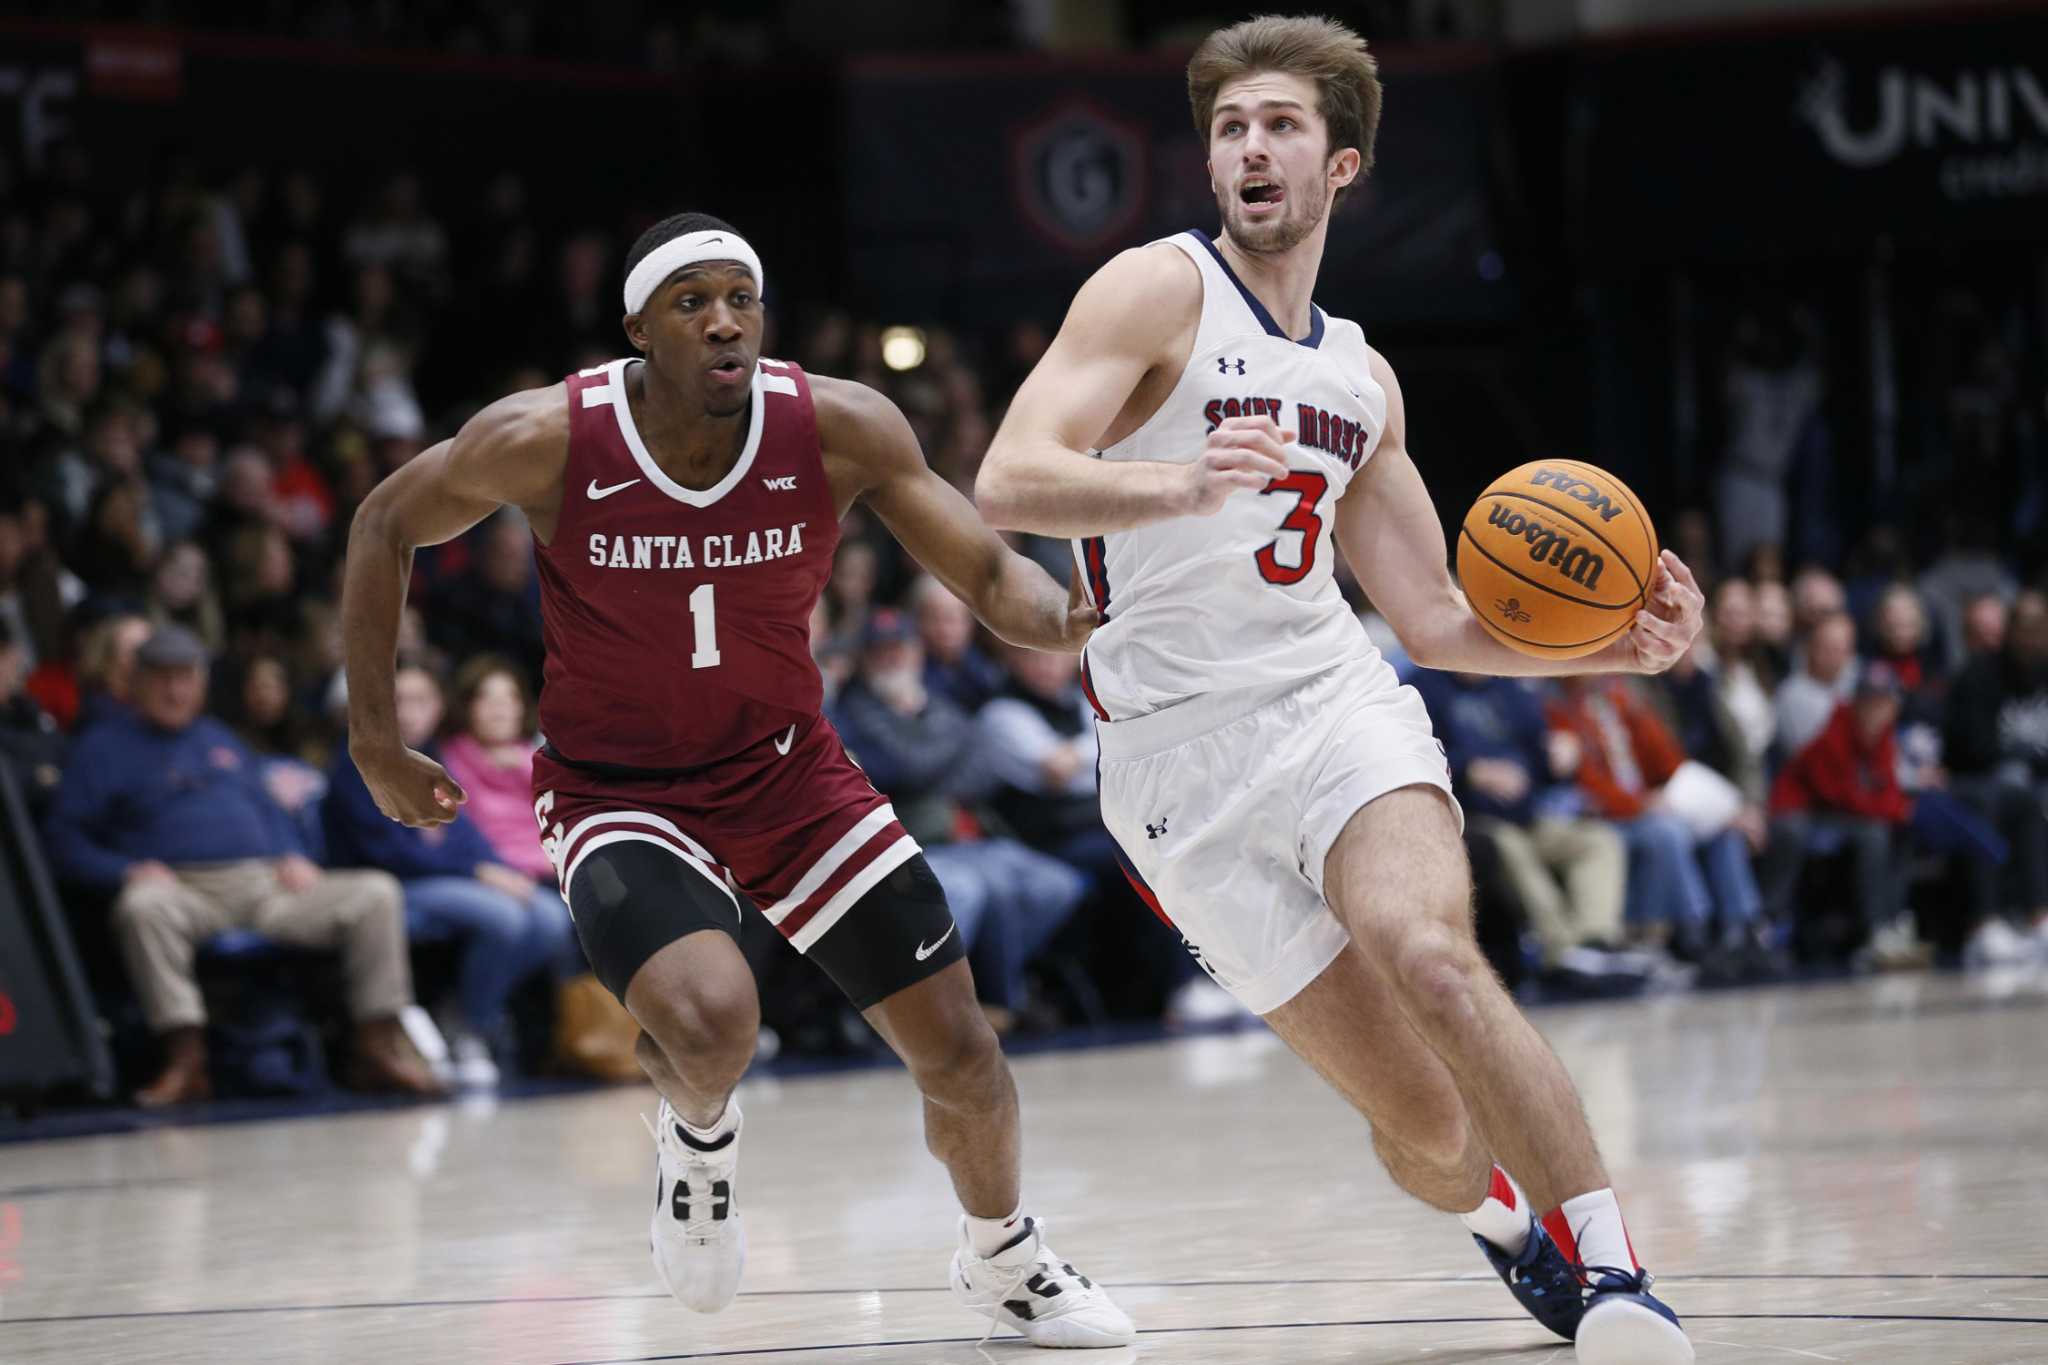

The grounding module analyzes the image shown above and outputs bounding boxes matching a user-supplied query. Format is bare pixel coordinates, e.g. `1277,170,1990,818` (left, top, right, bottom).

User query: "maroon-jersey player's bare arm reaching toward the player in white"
811,375,1100,653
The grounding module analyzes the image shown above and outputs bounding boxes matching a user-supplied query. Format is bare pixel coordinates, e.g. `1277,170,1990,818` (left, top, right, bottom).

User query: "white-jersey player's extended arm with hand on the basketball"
1335,350,1706,675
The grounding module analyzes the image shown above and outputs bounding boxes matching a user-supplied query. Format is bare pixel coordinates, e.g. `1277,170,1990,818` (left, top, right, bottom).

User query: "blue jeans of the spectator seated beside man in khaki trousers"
406,876,575,1036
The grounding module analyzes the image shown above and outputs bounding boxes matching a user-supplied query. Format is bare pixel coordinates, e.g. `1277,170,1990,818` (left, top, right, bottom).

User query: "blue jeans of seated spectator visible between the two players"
924,839,1087,1009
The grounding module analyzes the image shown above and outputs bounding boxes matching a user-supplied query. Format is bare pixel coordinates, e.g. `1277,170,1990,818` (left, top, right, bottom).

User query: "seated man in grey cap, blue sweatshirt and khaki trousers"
47,626,438,1107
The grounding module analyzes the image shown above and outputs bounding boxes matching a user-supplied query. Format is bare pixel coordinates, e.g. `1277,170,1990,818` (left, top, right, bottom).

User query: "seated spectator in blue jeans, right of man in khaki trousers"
324,665,573,1089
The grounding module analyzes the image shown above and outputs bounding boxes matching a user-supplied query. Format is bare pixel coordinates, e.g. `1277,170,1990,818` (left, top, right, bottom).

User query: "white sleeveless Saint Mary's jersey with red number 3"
1073,231,1386,720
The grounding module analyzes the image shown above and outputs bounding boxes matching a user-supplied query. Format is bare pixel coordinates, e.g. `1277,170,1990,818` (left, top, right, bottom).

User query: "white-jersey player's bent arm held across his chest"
975,246,1288,538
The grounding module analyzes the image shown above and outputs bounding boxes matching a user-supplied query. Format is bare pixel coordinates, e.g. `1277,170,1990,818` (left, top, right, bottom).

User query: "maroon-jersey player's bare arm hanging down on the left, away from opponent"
342,385,569,825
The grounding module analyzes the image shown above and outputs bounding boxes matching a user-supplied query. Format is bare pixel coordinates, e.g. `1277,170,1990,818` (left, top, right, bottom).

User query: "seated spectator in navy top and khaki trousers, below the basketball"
1415,669,1628,976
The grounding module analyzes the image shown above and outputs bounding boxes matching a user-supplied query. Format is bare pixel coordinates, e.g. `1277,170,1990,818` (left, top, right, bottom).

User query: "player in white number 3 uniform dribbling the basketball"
977,18,1702,1365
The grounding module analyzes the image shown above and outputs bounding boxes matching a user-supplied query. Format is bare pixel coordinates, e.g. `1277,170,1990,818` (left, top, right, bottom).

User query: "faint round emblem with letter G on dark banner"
1012,98,1145,252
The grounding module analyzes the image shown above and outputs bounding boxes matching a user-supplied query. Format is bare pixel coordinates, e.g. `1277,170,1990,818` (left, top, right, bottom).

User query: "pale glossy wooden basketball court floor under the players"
0,976,2048,1365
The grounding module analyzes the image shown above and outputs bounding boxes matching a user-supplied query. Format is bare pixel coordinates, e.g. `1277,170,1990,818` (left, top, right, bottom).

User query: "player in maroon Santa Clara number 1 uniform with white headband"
342,213,1133,1347
